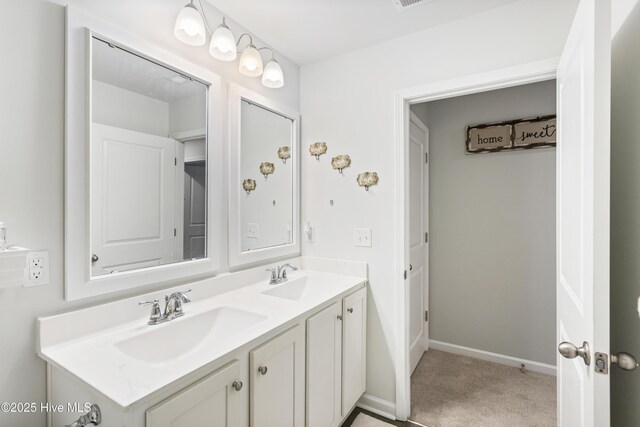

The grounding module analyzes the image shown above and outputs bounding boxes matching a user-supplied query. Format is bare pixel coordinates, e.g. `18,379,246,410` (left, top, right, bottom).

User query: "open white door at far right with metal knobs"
556,0,611,427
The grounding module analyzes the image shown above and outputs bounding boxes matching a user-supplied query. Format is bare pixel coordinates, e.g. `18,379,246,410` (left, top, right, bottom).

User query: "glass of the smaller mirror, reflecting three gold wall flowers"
238,99,295,252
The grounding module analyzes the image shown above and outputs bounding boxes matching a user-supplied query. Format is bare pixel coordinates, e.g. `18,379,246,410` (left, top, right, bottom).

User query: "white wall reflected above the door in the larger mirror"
91,80,170,137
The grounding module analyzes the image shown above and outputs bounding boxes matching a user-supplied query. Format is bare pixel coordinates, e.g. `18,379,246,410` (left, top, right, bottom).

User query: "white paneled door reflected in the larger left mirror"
91,123,176,275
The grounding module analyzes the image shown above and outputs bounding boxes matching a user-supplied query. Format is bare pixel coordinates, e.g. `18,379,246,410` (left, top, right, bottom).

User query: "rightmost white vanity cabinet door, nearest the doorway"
342,288,367,416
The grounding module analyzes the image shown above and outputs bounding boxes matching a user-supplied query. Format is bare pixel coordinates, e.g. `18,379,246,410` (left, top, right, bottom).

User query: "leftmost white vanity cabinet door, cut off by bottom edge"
147,360,246,427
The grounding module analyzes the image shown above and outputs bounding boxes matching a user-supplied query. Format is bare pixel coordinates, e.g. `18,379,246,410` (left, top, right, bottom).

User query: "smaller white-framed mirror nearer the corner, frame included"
229,84,300,267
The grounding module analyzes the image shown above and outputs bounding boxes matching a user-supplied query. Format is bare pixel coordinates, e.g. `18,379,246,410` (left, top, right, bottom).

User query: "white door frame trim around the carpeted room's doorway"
394,58,559,421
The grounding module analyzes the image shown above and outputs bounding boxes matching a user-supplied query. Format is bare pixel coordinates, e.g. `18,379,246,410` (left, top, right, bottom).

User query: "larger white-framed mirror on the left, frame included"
65,9,222,300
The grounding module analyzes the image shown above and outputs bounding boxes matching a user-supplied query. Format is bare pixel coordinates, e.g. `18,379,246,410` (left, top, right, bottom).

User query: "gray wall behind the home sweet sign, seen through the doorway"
414,81,556,365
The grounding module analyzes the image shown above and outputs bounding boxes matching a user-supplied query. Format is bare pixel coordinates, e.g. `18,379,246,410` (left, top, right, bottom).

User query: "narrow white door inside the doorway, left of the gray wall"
409,113,429,372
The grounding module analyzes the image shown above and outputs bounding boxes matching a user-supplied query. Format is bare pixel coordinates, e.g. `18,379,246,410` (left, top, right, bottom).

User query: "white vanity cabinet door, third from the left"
307,301,343,427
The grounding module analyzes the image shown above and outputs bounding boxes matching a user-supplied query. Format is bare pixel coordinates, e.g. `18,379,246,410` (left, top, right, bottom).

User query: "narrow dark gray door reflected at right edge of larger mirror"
184,162,207,259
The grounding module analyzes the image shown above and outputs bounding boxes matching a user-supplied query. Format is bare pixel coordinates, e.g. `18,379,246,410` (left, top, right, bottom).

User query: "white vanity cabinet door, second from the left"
249,326,305,427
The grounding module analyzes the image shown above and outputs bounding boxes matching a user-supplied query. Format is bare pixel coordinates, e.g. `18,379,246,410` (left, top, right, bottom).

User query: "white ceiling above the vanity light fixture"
205,0,517,65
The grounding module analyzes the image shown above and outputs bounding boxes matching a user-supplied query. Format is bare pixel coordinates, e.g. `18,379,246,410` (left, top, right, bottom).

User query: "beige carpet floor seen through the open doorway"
411,350,557,427
